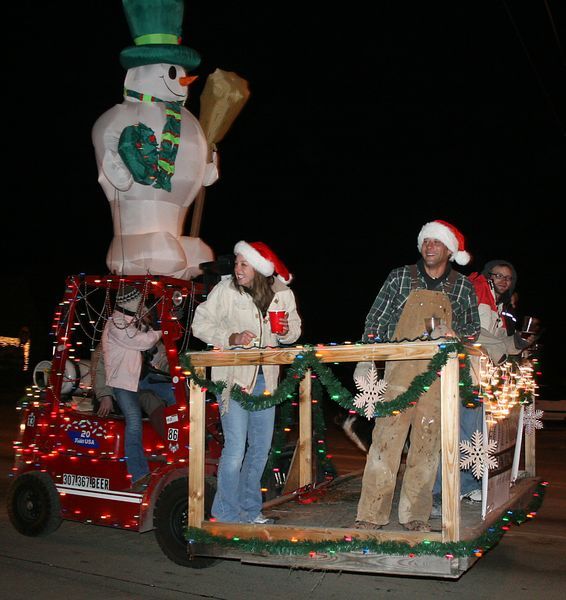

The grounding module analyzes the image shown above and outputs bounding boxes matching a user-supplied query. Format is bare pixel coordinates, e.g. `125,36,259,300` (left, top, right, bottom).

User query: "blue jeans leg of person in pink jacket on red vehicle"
112,388,149,482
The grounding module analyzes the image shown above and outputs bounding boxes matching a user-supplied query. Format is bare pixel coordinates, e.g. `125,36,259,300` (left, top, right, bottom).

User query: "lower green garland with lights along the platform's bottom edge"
186,482,548,558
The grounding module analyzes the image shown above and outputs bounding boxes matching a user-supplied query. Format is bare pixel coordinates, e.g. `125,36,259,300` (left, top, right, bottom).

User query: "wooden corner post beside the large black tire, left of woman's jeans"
188,367,206,527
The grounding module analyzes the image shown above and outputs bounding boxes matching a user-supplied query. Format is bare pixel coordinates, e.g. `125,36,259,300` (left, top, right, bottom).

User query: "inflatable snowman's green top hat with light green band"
120,0,200,71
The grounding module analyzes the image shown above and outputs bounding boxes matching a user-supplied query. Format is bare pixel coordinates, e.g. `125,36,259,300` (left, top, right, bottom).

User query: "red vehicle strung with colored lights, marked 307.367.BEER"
8,275,222,562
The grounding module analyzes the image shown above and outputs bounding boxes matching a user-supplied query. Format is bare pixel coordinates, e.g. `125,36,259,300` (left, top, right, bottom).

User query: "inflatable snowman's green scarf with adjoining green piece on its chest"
118,90,183,192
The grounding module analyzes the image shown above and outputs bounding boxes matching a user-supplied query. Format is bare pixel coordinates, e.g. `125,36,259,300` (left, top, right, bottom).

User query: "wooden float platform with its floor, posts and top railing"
187,342,540,579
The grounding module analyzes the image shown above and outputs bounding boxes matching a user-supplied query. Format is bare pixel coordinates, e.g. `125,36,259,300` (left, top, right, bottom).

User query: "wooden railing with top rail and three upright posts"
188,341,473,542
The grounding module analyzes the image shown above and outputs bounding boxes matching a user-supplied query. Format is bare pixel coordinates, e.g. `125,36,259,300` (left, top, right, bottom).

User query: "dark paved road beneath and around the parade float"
0,386,566,600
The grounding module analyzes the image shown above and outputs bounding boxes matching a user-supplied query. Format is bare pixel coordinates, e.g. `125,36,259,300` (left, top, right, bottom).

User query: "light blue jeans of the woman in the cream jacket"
212,371,275,523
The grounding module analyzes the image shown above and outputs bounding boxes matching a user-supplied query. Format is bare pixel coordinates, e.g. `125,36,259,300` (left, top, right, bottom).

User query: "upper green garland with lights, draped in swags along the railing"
181,342,481,417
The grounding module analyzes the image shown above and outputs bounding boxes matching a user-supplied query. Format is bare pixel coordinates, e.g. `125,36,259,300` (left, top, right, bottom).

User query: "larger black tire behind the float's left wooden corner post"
153,477,216,569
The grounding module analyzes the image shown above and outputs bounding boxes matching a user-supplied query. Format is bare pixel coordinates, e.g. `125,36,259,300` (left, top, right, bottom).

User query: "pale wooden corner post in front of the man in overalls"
440,353,460,542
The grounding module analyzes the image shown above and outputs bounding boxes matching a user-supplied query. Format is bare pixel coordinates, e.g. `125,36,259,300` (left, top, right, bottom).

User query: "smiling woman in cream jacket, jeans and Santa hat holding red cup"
192,241,301,524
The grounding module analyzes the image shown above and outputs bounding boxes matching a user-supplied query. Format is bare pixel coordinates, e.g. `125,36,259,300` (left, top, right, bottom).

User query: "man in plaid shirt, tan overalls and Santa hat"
355,220,480,531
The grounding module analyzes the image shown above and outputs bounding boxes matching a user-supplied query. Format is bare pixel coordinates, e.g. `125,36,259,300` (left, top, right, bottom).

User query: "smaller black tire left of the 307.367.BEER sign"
7,472,62,537
